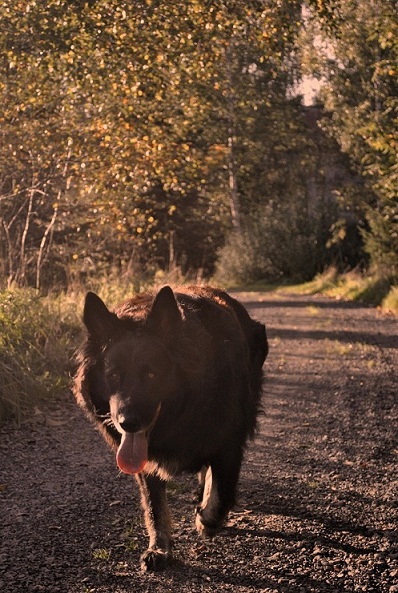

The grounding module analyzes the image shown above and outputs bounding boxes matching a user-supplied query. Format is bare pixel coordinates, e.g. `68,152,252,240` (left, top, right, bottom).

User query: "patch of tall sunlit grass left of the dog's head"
0,289,81,423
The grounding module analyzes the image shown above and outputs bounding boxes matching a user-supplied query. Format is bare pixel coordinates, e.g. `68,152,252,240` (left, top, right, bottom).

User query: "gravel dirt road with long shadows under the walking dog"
0,293,398,593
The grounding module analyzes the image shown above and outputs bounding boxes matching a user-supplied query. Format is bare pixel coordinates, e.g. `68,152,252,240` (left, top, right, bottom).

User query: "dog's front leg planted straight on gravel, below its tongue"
136,474,171,571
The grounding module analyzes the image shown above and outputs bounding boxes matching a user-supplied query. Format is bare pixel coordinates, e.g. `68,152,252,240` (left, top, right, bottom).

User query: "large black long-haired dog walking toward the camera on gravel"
74,286,268,570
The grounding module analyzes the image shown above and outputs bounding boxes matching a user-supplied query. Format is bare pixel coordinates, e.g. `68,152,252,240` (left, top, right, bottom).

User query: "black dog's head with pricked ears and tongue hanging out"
83,286,182,473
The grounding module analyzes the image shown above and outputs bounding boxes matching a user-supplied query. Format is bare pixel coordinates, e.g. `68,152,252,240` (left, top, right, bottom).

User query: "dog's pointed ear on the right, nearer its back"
146,286,182,339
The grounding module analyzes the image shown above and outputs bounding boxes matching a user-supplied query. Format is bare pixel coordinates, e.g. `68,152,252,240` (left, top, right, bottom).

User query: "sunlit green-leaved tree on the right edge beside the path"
307,0,398,276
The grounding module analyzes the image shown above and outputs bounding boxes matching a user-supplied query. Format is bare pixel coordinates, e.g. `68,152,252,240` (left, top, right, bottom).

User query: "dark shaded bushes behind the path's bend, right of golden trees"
215,100,356,285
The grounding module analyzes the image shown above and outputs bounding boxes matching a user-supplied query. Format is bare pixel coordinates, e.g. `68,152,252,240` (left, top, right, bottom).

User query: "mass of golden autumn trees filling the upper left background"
0,0,300,288
